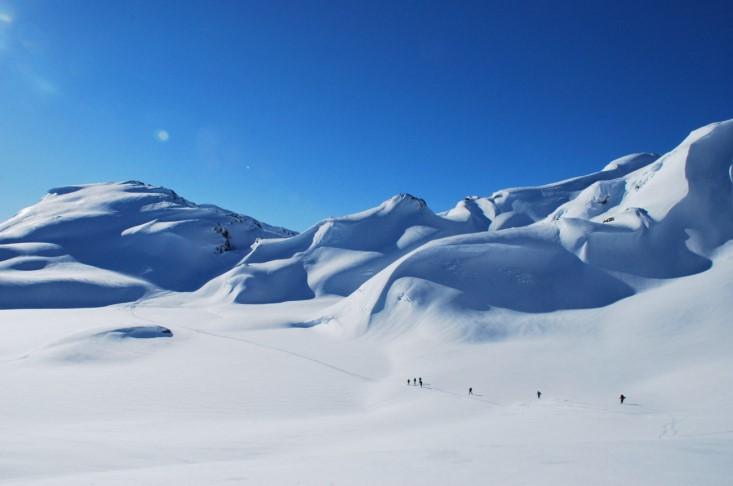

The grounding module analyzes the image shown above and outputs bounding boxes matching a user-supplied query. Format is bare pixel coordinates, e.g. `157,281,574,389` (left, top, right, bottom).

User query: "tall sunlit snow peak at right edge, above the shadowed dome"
550,121,733,278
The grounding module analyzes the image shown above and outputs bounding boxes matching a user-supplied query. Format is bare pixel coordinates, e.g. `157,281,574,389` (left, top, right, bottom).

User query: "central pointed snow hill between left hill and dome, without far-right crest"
197,194,489,303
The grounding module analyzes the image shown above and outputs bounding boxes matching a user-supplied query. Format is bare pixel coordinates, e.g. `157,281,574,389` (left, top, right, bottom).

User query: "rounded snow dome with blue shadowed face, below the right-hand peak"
336,223,634,335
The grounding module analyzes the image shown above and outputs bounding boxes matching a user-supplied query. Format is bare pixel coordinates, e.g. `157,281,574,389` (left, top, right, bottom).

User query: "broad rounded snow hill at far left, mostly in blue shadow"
0,181,295,308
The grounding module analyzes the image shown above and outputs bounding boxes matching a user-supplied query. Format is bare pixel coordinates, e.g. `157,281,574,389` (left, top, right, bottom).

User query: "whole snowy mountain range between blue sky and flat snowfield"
0,121,733,316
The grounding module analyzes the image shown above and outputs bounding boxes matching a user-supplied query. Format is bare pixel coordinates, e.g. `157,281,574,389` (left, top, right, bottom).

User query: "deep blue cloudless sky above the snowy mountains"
0,0,733,230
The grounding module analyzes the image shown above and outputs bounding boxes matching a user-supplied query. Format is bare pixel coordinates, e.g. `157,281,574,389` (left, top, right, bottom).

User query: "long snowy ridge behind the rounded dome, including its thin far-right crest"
201,154,657,303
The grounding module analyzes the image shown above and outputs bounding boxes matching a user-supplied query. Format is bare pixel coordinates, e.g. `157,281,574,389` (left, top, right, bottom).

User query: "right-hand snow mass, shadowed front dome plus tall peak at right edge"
333,121,733,334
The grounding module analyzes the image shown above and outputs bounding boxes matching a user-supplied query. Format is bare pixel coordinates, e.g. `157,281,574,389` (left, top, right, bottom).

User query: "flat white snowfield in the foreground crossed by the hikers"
0,241,733,486
